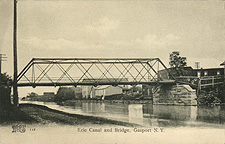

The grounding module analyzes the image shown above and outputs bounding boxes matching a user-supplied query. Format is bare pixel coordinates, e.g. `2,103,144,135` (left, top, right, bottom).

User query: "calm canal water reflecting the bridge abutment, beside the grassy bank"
20,101,225,128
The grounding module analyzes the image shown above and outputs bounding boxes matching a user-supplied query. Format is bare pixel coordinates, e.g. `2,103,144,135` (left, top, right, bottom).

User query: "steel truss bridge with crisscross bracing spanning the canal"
17,58,175,87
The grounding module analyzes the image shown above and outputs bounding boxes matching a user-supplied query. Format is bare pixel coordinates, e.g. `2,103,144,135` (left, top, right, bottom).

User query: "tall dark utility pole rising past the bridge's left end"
13,0,18,107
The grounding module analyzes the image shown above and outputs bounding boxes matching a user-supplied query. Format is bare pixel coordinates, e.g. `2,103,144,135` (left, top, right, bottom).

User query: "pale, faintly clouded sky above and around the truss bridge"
0,0,225,96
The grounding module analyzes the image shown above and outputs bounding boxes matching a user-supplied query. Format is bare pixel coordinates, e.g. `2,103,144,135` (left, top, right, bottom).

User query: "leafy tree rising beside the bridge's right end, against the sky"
169,51,190,76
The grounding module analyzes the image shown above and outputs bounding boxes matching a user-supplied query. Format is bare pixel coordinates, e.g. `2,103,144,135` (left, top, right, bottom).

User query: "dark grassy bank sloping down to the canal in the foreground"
0,104,137,127
